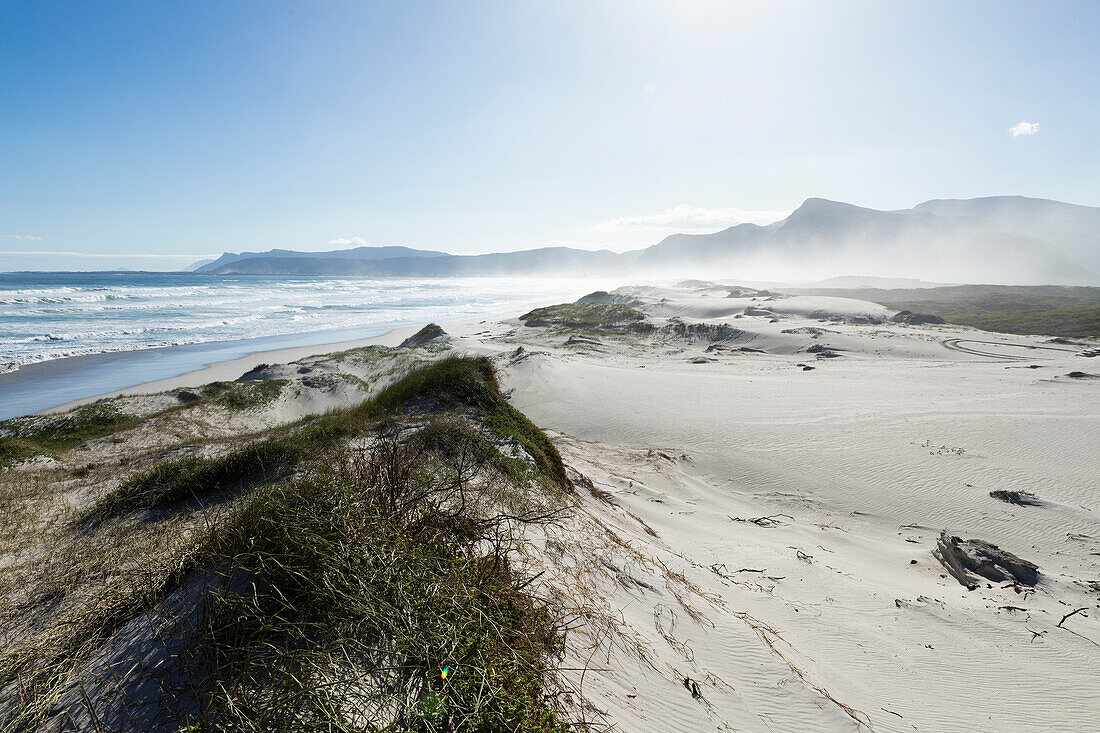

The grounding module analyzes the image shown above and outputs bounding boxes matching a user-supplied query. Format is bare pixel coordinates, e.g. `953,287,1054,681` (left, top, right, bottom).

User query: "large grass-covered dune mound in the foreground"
0,358,570,733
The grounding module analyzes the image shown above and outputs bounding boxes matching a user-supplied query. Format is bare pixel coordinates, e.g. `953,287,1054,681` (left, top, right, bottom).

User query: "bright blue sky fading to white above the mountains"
0,0,1100,270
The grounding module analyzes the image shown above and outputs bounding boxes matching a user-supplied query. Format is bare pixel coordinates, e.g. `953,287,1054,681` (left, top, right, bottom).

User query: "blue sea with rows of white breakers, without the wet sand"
0,273,601,371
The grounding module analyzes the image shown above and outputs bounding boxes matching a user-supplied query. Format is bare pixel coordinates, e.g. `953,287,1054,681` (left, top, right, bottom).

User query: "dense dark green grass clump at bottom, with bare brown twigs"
194,462,569,733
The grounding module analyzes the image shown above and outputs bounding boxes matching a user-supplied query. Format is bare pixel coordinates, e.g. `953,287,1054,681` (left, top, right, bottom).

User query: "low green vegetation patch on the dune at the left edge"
0,402,140,467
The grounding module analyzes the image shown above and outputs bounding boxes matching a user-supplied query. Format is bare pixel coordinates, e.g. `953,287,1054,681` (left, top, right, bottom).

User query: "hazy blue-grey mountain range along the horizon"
195,196,1100,285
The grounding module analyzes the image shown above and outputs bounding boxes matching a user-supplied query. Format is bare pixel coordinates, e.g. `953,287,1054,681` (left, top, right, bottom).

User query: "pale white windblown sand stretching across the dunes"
4,285,1100,732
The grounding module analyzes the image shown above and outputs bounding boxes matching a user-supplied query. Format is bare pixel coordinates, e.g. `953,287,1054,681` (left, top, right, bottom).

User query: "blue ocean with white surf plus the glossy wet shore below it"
0,272,605,419
